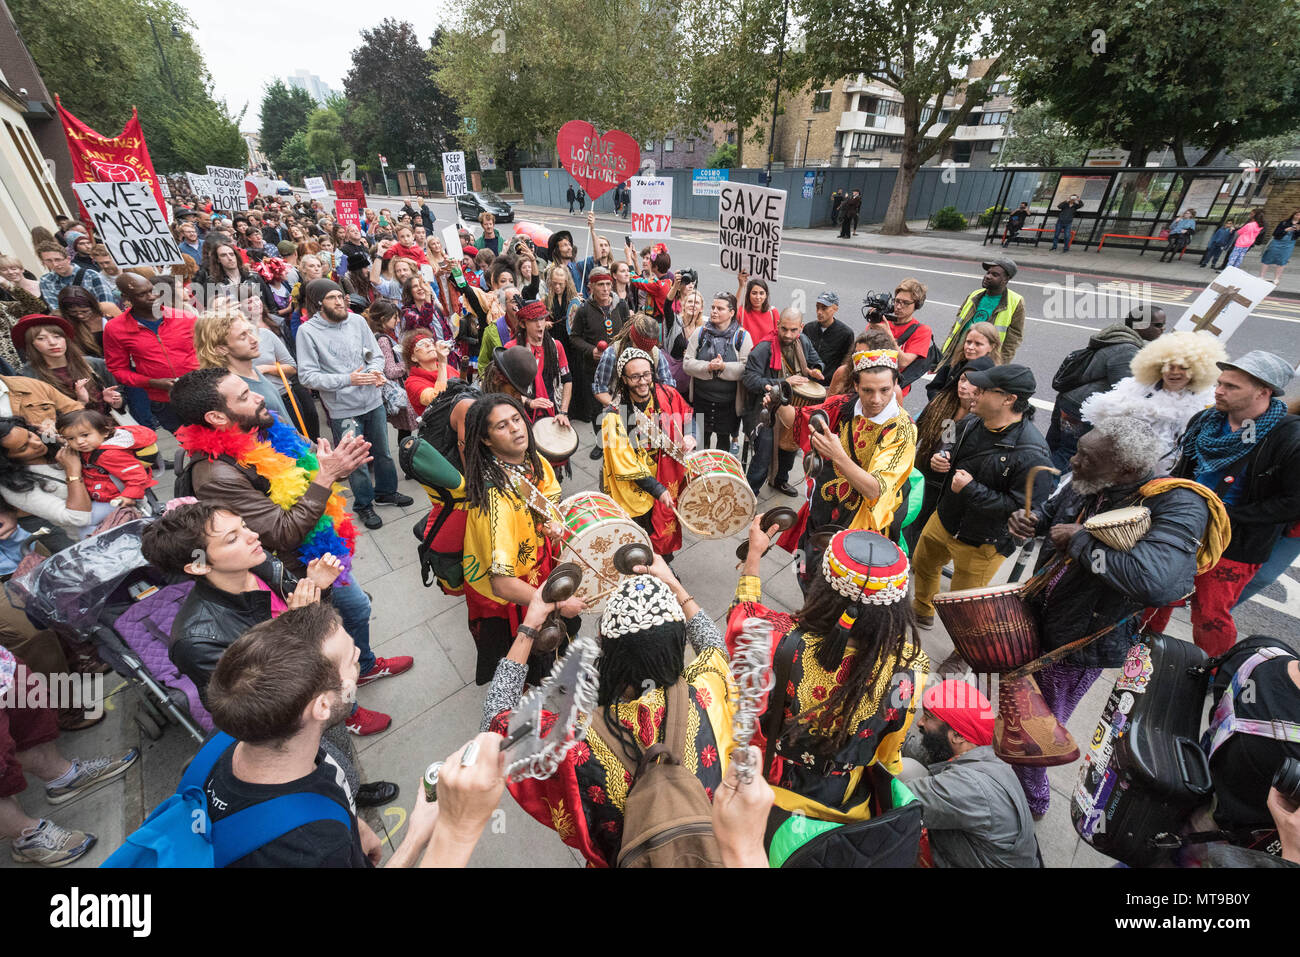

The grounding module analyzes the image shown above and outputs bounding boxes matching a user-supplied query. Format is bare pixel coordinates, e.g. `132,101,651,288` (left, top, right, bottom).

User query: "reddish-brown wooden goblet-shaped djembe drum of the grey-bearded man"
933,584,1079,767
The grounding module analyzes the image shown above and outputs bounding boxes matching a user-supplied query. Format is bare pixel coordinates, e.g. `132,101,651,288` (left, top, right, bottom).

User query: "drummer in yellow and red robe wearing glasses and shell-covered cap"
601,347,696,559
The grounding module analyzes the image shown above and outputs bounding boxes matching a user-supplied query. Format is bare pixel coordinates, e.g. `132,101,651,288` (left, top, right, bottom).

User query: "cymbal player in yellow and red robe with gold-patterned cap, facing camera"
779,350,917,590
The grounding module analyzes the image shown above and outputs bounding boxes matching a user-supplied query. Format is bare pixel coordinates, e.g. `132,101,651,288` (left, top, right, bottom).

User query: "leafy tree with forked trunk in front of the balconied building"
783,0,1036,235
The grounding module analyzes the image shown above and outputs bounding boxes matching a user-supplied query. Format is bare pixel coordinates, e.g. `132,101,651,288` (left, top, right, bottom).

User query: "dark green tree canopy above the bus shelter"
1017,0,1300,166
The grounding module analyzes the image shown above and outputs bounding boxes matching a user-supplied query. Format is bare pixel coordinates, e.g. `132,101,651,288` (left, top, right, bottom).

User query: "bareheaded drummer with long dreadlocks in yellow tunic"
462,393,585,684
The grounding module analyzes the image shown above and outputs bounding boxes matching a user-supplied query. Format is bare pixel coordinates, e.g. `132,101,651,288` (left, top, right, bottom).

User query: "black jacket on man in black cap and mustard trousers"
937,416,1053,555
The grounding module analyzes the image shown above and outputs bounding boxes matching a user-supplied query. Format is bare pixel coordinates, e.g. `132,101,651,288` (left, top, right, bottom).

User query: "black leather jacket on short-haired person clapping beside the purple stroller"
168,558,298,706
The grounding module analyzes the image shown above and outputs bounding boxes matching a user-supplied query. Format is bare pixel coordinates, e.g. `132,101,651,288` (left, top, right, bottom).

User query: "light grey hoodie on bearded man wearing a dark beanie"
298,312,384,419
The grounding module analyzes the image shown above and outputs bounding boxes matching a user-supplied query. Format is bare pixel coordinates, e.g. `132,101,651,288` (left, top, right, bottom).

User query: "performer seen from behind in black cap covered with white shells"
482,555,736,867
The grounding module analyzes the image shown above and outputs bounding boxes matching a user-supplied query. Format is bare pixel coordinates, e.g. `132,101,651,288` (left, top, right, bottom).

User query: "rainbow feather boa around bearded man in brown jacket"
176,412,356,583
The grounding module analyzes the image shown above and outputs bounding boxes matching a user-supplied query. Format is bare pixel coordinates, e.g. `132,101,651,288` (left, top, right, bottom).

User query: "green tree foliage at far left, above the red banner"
8,0,247,173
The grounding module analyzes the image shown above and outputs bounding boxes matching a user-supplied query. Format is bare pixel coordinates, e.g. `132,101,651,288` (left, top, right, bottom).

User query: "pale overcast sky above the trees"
182,0,446,130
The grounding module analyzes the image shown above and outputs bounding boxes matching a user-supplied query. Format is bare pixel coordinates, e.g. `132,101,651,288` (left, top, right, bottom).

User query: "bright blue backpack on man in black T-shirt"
101,731,352,867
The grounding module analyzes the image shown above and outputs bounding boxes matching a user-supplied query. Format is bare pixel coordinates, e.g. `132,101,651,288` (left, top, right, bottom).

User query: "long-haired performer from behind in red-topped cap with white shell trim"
727,516,930,863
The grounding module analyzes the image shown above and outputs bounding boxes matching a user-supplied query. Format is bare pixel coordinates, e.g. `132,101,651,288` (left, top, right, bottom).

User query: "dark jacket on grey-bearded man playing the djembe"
1030,479,1209,668
